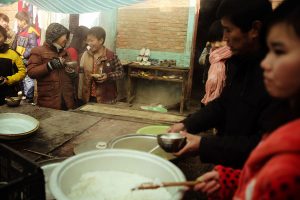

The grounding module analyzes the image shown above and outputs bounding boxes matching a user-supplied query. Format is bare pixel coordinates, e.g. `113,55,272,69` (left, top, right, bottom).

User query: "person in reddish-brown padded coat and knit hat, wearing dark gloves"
28,23,77,110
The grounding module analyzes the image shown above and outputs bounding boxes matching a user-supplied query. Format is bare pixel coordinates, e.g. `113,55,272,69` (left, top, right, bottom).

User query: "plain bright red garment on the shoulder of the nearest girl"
234,119,300,200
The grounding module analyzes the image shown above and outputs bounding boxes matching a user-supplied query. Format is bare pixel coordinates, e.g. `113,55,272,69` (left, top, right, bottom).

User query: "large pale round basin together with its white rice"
50,149,186,200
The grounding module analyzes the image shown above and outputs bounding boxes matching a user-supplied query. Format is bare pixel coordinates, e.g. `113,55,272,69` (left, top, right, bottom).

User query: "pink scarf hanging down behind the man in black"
201,46,232,105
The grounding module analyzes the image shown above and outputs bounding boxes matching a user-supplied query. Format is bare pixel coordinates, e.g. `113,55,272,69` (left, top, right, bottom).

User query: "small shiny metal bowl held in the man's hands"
157,133,186,153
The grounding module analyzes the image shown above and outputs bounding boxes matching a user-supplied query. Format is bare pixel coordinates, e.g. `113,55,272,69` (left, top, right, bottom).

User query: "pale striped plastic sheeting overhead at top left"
26,0,144,14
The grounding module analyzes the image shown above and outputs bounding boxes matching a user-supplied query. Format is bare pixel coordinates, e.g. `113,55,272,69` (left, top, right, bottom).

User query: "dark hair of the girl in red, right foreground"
268,0,300,37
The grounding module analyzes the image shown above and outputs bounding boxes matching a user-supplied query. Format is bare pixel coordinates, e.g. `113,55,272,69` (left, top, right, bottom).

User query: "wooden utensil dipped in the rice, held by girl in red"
131,180,202,191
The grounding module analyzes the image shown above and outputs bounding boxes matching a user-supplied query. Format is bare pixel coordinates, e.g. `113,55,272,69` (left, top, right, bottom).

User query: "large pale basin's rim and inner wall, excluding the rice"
50,149,186,200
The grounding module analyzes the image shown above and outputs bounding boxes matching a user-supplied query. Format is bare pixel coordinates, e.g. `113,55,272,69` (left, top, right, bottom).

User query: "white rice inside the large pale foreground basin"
68,171,172,200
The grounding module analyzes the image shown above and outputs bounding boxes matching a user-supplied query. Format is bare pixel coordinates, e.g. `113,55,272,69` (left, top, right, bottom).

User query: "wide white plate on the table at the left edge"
0,113,39,139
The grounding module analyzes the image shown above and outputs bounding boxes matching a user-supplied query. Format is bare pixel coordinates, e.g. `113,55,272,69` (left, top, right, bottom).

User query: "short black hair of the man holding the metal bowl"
217,0,272,32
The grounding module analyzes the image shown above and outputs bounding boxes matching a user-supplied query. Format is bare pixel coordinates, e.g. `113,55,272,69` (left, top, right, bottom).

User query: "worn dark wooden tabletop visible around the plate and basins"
0,104,211,200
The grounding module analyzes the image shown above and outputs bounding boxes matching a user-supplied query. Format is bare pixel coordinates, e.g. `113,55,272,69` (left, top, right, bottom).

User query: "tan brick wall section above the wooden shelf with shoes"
117,0,189,53
